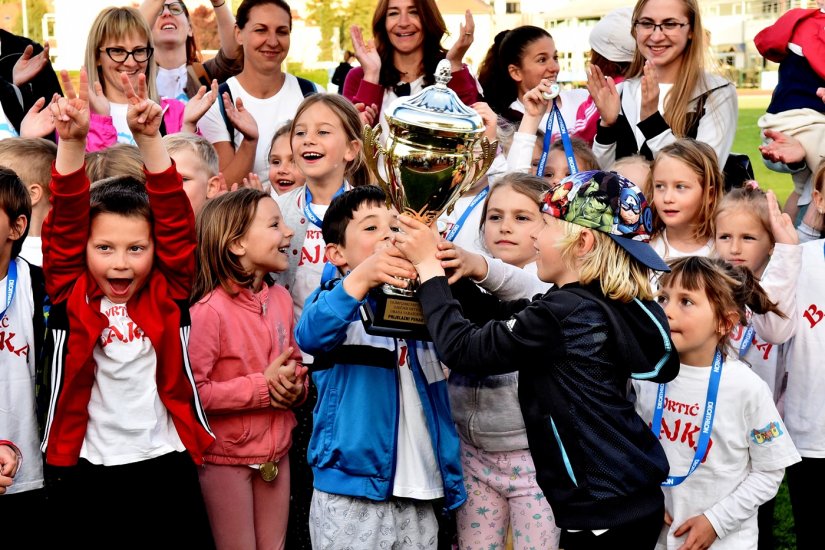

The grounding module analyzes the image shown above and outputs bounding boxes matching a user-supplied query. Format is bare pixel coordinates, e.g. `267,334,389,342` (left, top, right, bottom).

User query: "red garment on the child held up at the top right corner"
753,8,825,78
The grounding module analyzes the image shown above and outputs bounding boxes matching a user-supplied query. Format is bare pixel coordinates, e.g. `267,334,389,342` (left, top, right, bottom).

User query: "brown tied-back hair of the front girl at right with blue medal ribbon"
659,256,787,345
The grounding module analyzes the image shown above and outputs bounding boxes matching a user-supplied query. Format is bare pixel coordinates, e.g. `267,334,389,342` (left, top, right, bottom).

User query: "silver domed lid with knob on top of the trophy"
385,59,484,137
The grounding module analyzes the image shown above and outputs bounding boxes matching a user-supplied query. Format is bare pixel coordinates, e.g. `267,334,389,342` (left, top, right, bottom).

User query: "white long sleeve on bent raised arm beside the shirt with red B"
753,243,802,344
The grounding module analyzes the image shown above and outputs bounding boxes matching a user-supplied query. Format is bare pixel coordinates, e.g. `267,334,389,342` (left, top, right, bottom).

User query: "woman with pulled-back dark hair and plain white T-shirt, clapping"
198,0,317,191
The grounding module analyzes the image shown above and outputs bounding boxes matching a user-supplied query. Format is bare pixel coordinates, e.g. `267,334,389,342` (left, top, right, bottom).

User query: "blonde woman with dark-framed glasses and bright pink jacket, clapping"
83,7,217,152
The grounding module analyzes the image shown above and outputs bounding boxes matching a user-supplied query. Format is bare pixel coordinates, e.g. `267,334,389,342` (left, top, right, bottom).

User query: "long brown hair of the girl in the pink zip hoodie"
192,189,269,304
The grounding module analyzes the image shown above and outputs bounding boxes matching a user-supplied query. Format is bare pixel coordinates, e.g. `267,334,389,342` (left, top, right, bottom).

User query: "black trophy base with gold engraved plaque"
360,288,432,341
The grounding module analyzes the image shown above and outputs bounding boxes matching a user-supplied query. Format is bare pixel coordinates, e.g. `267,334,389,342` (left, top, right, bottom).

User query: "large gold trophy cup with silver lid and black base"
361,60,498,340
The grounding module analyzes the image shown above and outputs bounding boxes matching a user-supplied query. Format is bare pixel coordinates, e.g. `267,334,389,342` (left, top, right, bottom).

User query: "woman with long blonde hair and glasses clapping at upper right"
587,0,738,170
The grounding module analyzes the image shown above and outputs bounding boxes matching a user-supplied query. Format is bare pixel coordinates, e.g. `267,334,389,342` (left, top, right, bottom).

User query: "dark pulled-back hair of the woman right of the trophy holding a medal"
478,25,552,113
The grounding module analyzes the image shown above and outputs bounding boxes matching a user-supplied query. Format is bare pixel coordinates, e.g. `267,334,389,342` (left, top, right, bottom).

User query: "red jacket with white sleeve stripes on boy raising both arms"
42,165,214,466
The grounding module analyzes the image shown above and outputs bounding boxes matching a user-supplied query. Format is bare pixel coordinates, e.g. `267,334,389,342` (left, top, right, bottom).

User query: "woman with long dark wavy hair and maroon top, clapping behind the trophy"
343,0,478,125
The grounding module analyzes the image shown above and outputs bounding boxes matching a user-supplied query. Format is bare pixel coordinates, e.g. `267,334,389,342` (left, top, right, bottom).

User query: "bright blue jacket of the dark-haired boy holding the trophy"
295,279,467,509
